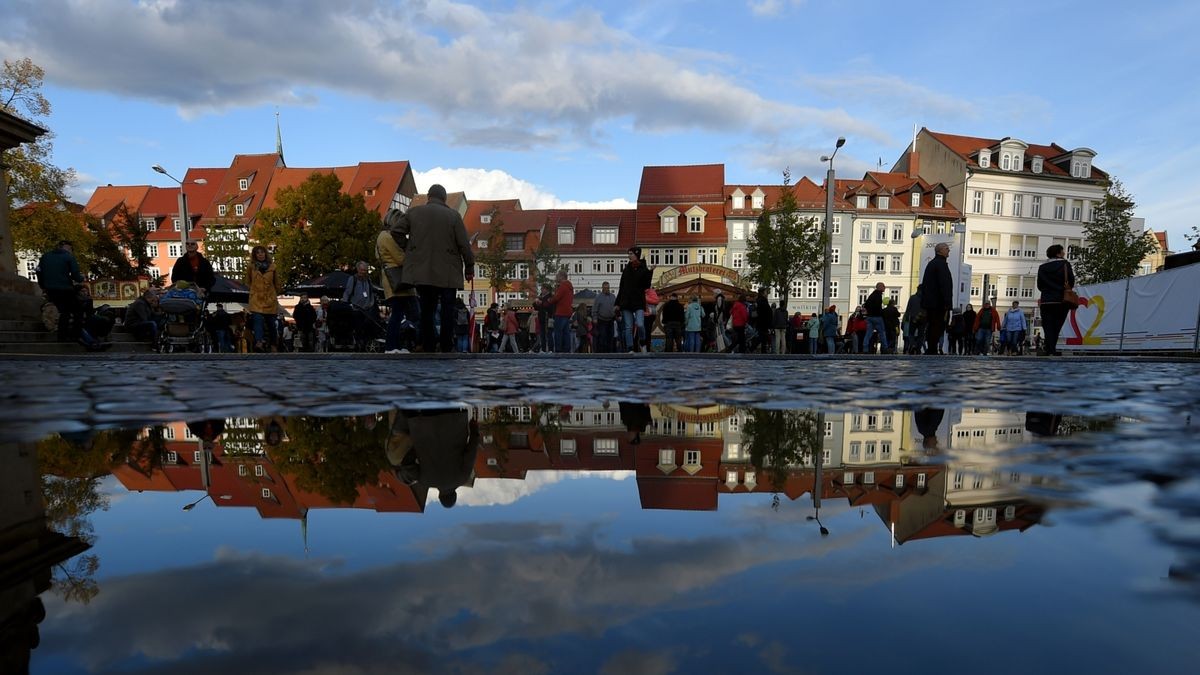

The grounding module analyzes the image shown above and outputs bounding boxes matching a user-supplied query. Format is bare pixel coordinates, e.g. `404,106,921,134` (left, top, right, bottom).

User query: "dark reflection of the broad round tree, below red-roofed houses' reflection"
266,414,389,504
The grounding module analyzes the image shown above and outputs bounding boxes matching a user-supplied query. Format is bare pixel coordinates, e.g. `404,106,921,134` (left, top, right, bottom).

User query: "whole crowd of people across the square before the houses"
30,185,1075,356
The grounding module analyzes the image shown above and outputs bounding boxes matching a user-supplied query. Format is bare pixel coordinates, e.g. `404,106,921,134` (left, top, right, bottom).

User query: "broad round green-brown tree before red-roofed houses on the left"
250,172,383,285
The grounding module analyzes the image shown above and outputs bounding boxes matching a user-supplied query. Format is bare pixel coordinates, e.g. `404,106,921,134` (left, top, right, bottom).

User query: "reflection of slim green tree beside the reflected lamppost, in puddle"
742,408,821,491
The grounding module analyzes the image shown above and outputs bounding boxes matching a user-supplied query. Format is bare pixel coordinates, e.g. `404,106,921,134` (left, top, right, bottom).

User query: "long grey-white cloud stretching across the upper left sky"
0,0,886,149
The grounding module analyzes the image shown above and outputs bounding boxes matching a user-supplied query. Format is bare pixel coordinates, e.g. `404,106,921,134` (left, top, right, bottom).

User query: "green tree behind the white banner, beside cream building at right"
1074,179,1156,283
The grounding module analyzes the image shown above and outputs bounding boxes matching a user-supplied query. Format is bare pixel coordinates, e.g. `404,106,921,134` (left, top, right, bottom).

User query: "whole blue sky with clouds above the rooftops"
0,0,1200,250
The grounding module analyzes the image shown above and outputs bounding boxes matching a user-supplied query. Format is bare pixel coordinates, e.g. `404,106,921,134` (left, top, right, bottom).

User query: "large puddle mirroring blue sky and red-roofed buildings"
9,404,1200,673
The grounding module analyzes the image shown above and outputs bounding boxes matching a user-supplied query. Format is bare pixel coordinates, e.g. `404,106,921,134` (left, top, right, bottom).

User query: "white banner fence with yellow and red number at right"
1060,260,1200,352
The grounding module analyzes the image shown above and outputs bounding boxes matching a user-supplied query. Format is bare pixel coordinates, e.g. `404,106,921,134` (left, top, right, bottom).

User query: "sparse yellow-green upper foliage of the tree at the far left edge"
0,58,74,207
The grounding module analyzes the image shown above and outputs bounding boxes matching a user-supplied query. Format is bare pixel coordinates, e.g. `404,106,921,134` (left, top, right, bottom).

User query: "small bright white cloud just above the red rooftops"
413,167,636,209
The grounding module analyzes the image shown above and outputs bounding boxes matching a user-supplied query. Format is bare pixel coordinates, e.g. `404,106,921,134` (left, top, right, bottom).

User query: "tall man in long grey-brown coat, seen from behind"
384,184,475,352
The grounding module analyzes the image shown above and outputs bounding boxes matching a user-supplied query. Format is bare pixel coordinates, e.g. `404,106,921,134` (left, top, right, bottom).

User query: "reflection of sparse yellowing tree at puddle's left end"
37,430,137,604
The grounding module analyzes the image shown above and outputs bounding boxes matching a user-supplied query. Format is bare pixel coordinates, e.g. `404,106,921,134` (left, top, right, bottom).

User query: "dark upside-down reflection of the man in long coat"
388,408,479,508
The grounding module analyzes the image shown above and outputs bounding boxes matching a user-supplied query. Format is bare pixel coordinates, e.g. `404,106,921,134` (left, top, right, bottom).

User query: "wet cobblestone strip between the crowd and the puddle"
0,354,1200,441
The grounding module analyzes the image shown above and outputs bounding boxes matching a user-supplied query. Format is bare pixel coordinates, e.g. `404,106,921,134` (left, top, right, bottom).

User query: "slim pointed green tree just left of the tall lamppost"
746,169,829,309
